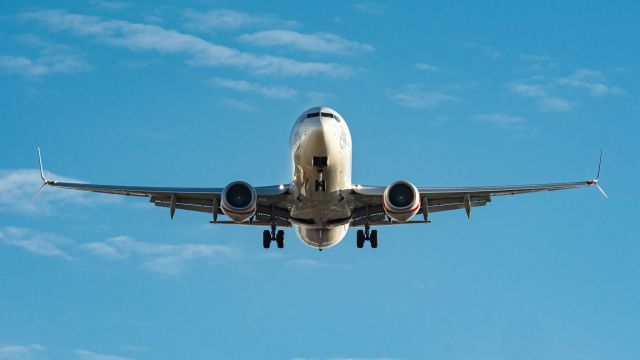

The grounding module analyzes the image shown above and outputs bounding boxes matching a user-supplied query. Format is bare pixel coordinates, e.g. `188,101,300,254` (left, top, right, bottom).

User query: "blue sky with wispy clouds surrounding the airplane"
0,1,640,360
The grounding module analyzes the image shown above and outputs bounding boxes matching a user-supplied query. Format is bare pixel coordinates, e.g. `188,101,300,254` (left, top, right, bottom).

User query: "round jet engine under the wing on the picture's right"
382,181,420,222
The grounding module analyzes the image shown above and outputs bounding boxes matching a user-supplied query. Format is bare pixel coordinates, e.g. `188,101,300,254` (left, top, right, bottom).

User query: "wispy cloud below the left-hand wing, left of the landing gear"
82,236,240,276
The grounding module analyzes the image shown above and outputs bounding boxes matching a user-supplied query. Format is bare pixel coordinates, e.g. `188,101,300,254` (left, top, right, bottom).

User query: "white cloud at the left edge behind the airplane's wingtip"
0,169,119,215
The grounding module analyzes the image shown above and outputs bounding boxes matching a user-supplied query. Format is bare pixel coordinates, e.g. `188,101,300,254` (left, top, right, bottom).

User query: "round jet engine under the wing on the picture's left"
220,181,258,222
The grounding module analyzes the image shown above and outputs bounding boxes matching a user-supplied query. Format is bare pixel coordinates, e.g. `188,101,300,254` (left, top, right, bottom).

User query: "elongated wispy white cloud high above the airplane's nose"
238,30,374,55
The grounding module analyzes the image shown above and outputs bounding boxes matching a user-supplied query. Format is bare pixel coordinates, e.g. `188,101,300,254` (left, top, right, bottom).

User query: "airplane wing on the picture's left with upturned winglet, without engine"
38,149,291,227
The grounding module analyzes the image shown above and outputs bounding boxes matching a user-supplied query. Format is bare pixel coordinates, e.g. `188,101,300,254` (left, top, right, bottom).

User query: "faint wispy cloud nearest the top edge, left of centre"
184,9,297,32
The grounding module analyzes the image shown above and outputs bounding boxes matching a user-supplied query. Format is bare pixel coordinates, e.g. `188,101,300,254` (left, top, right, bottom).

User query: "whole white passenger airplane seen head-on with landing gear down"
38,106,607,251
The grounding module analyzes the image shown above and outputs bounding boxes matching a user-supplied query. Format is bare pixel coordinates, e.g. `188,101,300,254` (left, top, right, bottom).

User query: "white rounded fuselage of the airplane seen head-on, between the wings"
290,107,352,249
